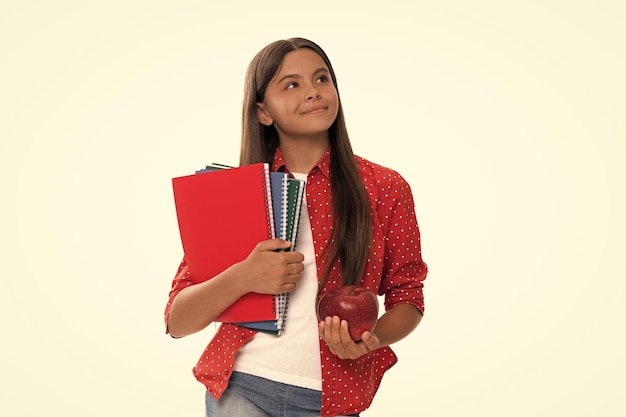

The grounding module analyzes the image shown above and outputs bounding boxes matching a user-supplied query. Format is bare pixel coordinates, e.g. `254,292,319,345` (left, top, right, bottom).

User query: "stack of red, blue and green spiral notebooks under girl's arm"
172,163,304,335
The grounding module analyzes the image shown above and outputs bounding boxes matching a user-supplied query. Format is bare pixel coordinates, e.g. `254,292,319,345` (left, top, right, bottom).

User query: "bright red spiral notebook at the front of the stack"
172,163,276,322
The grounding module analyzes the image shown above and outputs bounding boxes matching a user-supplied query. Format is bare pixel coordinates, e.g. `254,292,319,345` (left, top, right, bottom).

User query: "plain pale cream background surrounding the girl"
0,0,626,417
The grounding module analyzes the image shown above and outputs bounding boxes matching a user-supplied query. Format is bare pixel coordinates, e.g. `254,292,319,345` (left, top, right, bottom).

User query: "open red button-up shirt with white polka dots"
165,150,427,416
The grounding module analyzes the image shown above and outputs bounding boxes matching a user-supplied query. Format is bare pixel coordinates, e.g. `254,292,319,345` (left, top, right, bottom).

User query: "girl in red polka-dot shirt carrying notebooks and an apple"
165,38,427,417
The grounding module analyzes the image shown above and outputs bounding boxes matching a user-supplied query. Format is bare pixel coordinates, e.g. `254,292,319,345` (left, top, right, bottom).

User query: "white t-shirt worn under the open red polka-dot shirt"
235,174,322,391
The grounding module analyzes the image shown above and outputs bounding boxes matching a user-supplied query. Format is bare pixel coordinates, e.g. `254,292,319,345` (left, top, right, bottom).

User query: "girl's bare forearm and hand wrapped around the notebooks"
167,239,304,337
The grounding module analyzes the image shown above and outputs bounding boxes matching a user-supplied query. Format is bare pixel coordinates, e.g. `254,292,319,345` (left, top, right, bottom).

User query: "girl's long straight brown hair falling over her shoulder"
239,38,372,291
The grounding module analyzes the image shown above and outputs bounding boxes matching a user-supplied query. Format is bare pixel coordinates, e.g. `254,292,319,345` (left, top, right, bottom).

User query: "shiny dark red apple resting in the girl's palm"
317,285,378,342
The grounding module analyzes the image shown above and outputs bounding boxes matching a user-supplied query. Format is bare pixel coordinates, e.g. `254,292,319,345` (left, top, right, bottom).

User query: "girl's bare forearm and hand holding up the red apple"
319,304,422,359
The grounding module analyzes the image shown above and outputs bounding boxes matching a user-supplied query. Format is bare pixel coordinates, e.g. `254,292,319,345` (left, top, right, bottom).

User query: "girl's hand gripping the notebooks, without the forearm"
237,239,304,294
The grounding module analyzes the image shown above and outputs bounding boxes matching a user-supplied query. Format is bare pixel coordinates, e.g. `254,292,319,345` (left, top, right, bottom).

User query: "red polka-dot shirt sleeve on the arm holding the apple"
378,171,428,314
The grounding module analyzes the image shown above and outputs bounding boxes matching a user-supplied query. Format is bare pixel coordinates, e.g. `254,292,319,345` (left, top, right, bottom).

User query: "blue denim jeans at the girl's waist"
205,372,358,417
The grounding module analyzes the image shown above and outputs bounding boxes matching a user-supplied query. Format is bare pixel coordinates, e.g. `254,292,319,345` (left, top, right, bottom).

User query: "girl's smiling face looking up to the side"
257,48,339,145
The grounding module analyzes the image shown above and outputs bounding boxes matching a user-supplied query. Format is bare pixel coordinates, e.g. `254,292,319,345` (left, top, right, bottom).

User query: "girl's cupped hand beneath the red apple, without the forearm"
318,316,380,359
